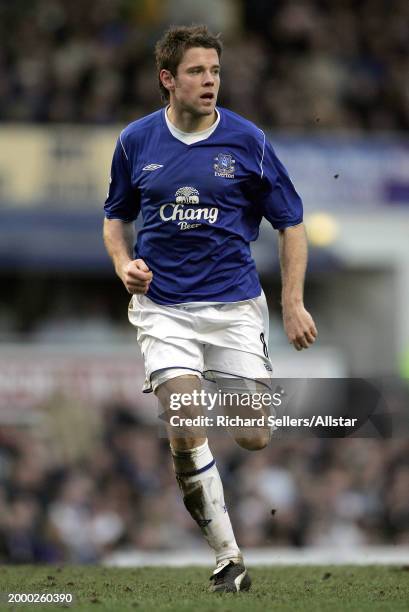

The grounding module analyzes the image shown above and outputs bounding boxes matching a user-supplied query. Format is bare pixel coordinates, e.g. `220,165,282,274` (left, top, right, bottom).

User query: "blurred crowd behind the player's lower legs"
0,405,409,563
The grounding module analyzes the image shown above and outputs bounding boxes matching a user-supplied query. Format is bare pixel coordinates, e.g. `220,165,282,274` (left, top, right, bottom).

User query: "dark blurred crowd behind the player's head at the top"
0,0,409,130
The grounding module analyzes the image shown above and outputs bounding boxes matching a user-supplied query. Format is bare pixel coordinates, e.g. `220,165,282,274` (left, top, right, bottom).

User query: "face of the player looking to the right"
165,47,220,116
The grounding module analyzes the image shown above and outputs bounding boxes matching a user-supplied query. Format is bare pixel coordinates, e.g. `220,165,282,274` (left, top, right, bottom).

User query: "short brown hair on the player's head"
155,25,223,102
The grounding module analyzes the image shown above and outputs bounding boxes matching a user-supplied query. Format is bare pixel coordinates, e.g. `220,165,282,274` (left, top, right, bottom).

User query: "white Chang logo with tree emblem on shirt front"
159,186,219,231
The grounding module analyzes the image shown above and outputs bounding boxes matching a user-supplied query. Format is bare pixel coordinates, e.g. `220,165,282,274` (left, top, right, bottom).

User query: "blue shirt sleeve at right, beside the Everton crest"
255,140,303,229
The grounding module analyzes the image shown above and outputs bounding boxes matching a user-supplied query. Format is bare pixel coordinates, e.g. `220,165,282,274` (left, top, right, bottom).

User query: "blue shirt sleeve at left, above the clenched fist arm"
104,137,140,222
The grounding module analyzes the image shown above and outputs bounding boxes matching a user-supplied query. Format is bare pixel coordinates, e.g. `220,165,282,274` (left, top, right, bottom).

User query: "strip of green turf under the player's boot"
0,566,409,612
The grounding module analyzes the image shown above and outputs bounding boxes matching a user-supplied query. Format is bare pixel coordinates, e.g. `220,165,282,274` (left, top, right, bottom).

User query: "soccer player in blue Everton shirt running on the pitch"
104,26,317,592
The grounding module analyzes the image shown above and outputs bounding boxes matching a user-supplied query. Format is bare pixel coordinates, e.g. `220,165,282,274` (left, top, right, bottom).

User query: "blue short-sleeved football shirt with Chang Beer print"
105,107,303,305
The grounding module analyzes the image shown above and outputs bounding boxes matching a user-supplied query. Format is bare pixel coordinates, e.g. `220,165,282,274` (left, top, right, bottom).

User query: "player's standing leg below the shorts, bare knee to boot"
152,370,251,591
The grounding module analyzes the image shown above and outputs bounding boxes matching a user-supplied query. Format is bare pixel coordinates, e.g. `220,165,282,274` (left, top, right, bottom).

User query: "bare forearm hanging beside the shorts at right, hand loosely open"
279,223,318,351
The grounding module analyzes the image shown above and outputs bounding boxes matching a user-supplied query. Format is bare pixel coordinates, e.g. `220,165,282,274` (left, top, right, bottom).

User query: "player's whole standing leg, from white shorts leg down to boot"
129,296,250,591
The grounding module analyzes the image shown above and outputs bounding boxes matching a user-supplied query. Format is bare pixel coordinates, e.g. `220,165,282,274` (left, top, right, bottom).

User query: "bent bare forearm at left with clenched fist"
104,219,152,293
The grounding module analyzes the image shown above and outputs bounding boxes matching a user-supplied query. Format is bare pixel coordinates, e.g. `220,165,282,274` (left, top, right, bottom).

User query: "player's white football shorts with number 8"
128,293,272,393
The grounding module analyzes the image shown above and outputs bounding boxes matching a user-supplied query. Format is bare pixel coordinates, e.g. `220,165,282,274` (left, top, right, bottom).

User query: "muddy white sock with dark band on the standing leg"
171,440,242,563
